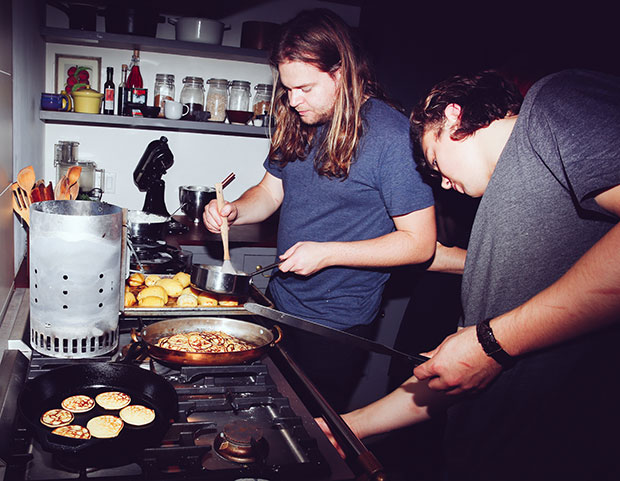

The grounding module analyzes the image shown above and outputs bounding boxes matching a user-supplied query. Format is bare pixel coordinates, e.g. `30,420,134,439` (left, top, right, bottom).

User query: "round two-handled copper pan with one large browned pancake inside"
128,317,282,366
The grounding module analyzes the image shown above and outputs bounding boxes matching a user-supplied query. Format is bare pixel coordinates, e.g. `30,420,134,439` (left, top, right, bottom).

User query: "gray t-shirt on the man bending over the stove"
445,71,620,481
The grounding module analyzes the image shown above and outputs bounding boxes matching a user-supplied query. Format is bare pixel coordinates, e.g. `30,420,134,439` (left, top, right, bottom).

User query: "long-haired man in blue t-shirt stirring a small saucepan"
204,9,436,409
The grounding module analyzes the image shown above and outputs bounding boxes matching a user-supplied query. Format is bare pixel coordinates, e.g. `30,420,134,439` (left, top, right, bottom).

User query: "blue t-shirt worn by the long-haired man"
264,99,433,329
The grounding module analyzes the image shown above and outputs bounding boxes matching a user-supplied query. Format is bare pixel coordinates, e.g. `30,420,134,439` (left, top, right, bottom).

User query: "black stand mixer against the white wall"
133,136,188,234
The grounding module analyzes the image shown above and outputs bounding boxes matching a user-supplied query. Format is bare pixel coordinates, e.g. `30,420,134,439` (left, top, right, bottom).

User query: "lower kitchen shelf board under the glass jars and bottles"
39,110,268,137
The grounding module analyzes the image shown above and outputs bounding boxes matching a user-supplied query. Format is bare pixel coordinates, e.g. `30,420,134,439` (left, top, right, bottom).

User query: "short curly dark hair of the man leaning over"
409,70,523,174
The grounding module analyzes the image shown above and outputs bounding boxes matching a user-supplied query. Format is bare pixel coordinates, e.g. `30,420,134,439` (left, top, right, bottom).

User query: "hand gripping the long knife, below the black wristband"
413,326,502,394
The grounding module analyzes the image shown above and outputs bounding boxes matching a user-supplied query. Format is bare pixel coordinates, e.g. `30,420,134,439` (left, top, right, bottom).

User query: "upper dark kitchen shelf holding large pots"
41,27,269,64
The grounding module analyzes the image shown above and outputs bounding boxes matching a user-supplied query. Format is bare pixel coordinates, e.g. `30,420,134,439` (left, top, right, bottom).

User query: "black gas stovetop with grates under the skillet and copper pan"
0,308,376,481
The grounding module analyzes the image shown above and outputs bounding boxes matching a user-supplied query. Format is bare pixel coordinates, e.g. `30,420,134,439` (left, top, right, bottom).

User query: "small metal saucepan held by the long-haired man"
190,262,280,297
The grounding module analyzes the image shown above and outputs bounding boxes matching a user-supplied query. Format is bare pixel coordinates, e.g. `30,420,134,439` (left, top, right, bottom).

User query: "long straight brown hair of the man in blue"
269,9,385,178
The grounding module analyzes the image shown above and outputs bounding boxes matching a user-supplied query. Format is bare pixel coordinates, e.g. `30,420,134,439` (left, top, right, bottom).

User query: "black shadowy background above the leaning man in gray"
359,0,620,108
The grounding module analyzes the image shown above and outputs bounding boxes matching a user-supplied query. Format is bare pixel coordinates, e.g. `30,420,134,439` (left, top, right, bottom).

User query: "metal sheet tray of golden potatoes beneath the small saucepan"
122,272,273,317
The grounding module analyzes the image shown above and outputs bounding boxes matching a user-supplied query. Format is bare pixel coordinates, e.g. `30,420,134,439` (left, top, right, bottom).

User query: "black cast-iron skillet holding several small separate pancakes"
18,362,178,467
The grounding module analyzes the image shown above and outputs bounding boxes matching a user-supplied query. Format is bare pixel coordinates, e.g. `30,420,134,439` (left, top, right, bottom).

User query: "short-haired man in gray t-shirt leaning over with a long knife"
322,70,620,481
